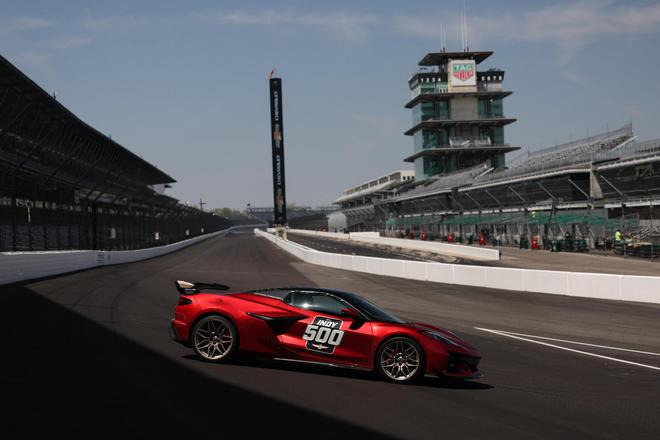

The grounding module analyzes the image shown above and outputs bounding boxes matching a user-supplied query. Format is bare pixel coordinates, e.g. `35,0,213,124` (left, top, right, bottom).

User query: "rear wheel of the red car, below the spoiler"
190,315,238,362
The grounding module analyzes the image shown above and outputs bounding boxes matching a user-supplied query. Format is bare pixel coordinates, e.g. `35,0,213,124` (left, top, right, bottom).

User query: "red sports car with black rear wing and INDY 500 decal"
169,281,481,383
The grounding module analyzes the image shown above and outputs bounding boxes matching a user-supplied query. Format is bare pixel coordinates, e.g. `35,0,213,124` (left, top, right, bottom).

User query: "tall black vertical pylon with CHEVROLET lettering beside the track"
270,78,286,225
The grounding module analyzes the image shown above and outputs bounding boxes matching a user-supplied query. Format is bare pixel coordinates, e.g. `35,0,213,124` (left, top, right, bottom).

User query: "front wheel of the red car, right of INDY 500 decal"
376,336,425,383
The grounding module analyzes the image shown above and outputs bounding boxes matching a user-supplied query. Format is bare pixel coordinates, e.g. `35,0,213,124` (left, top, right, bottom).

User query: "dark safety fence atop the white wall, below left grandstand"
0,197,231,251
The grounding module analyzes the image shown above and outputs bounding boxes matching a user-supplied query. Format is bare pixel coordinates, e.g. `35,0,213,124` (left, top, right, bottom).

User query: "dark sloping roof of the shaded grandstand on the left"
0,56,175,185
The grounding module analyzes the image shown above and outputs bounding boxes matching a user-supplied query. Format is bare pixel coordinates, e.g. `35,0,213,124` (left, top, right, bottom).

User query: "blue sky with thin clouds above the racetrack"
0,0,660,208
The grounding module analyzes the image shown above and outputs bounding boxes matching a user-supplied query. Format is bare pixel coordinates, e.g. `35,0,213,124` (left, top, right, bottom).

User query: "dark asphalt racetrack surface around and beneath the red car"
0,229,660,439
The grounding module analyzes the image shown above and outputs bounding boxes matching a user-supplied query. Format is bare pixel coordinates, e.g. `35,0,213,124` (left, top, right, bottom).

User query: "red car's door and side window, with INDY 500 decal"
278,290,373,367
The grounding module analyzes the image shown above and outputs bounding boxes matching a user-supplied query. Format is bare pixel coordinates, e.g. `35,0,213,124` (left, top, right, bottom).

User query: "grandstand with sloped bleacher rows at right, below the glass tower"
340,124,660,254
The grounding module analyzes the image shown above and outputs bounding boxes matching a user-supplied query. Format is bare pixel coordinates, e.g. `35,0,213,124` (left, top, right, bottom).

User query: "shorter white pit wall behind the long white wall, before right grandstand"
289,229,500,261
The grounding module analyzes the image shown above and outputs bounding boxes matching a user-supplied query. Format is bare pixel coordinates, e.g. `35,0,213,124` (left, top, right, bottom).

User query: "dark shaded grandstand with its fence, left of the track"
0,57,230,251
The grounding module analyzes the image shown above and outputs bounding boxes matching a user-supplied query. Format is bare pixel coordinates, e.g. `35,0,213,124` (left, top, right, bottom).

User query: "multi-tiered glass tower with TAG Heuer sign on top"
404,51,519,181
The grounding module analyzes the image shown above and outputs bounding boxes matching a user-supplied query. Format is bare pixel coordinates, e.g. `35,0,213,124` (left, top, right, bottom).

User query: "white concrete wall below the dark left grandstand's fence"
0,225,262,285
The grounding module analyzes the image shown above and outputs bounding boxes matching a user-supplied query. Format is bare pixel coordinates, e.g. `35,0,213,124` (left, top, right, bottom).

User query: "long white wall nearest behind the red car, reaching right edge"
255,229,660,304
